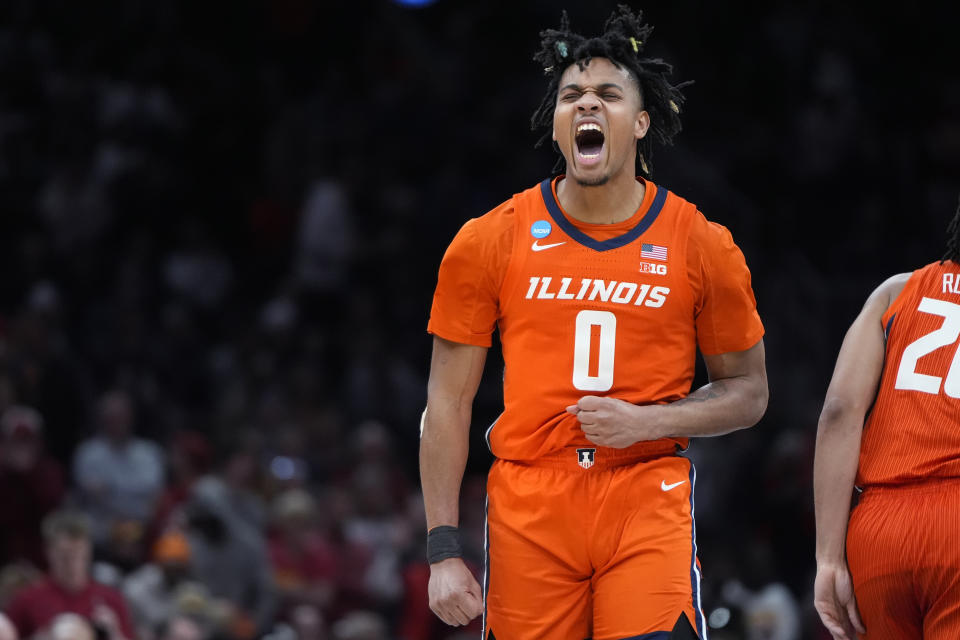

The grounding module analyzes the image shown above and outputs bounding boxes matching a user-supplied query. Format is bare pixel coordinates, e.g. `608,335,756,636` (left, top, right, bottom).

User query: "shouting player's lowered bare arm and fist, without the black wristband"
420,337,487,626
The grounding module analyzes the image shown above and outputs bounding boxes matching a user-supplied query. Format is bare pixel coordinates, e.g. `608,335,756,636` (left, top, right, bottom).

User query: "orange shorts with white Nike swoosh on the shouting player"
483,447,706,640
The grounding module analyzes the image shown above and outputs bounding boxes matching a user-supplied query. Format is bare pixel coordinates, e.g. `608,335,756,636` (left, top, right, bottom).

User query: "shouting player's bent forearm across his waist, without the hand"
659,375,768,438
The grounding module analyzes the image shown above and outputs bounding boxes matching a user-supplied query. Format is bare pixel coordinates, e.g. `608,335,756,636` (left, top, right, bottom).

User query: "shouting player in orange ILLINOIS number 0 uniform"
420,7,767,640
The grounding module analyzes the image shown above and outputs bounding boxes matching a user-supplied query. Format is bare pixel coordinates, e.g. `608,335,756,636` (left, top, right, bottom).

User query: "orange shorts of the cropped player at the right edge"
847,479,960,640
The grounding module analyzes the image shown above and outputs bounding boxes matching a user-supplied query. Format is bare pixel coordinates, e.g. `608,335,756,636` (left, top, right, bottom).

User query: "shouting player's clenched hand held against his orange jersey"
567,396,659,449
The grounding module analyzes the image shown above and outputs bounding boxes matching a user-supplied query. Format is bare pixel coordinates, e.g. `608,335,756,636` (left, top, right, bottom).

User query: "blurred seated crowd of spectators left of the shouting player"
0,400,483,640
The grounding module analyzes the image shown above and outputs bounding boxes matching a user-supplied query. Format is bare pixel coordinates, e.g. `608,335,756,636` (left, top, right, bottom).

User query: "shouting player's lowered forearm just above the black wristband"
420,400,470,530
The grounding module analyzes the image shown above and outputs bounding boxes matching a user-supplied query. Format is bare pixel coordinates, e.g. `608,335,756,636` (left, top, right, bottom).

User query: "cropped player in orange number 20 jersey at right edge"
814,209,960,640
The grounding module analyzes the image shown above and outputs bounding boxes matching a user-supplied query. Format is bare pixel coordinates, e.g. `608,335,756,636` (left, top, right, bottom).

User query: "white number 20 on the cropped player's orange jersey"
892,298,960,398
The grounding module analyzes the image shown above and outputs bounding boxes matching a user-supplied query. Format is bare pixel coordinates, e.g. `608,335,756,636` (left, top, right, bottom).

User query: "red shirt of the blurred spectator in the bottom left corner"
6,579,136,640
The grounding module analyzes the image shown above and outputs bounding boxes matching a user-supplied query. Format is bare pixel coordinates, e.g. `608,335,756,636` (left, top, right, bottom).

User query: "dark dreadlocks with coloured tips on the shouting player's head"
530,4,692,177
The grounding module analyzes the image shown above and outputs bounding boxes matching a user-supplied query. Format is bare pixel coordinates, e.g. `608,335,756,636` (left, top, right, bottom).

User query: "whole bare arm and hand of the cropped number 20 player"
814,274,909,640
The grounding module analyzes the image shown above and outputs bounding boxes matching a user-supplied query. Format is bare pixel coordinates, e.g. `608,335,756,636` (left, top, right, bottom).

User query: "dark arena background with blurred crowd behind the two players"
0,0,960,640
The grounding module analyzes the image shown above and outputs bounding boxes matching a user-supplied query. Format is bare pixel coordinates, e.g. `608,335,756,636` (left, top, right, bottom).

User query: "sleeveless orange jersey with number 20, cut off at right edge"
857,261,960,486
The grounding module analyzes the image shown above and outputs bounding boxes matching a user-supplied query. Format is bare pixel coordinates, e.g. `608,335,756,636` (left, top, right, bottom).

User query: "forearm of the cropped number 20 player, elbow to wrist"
813,399,865,564
